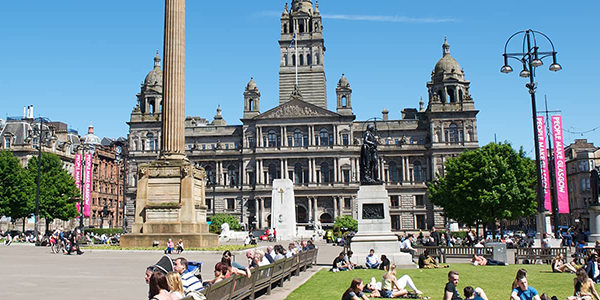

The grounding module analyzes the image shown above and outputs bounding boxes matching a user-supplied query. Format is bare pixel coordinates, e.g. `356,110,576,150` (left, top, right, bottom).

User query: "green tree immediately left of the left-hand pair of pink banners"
27,153,80,230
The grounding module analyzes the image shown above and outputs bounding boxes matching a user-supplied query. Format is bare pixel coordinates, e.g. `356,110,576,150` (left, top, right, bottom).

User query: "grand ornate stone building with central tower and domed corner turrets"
127,0,478,232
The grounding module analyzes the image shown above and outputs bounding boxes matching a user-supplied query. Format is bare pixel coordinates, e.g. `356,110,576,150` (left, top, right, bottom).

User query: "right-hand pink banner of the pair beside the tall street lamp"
551,116,569,214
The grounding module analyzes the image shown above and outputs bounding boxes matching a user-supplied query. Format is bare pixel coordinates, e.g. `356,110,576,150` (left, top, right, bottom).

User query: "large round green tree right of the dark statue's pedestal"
428,143,537,225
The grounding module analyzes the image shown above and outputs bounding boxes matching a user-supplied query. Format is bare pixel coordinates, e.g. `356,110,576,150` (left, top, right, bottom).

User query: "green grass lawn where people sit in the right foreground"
286,264,575,300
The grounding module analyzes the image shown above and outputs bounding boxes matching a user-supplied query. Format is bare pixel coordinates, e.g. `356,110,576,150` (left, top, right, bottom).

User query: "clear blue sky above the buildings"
0,0,600,153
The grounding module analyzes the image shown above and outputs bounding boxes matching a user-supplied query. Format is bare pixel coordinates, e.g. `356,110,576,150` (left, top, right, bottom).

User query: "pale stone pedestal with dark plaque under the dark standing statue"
350,185,415,268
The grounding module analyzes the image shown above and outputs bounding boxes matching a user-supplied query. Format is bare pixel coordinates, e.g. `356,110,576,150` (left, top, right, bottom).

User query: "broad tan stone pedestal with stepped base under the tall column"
121,160,218,247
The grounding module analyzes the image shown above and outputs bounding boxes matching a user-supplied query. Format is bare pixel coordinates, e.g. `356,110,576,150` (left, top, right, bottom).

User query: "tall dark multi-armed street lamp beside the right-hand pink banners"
500,29,562,239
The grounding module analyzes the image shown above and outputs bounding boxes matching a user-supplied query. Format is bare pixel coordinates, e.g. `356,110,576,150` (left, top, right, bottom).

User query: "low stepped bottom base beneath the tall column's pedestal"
121,233,219,249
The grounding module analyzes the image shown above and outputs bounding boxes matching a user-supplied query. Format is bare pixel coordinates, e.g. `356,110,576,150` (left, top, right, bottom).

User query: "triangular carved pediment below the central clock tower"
253,99,340,120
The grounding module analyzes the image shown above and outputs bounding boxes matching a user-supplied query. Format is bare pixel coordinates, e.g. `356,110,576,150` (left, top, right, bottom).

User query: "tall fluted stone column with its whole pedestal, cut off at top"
121,0,218,247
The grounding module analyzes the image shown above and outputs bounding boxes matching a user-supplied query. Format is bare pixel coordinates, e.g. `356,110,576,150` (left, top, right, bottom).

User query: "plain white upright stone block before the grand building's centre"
271,179,296,241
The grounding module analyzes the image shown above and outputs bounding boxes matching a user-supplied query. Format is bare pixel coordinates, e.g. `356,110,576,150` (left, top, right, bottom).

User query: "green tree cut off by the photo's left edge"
0,150,35,230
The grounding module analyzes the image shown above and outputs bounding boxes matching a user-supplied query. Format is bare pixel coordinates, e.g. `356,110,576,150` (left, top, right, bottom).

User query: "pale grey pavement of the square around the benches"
0,241,514,300
